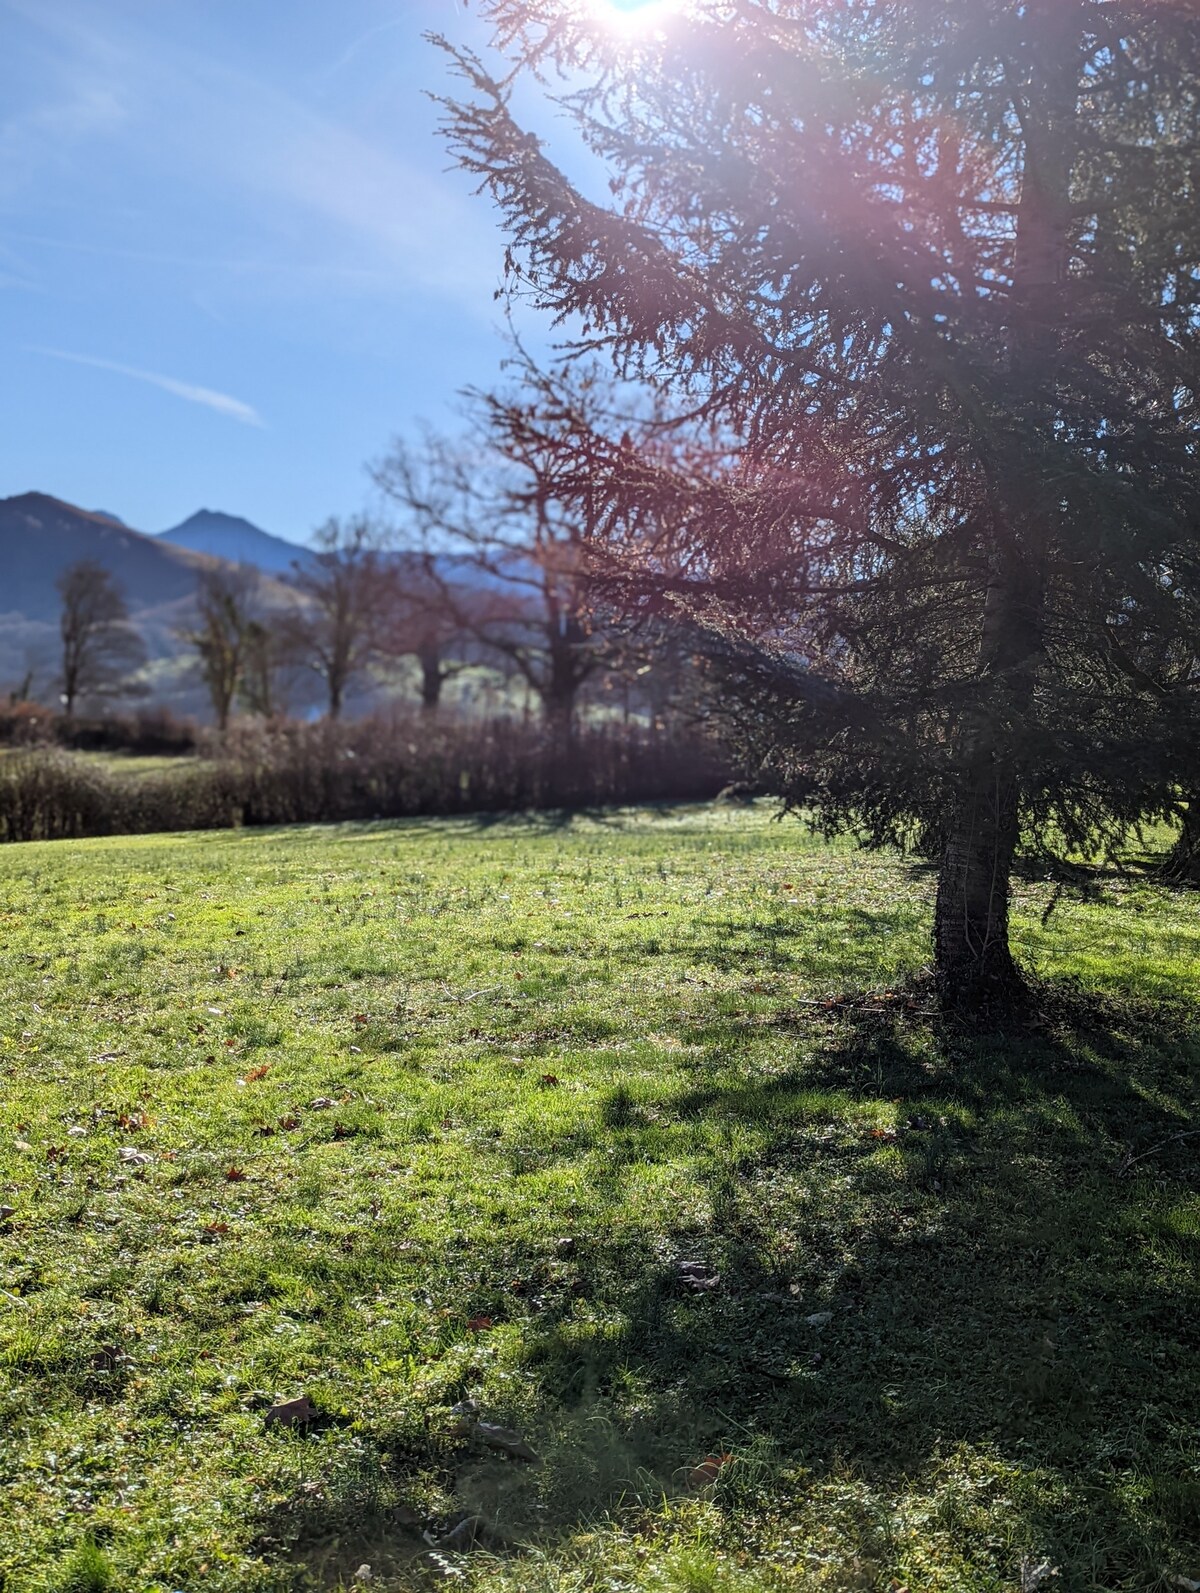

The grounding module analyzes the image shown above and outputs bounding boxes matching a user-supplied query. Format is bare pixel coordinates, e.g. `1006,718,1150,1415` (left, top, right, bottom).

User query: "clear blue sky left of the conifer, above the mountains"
0,0,551,540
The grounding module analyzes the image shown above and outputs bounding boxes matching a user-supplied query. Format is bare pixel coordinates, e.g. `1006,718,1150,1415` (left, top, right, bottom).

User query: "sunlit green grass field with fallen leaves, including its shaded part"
0,808,1200,1593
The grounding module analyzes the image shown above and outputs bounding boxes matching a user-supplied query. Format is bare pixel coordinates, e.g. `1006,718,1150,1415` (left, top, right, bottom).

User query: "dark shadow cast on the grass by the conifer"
258,989,1200,1593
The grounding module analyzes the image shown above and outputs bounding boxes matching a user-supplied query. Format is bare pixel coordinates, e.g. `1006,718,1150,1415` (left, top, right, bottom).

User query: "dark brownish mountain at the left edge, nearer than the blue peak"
0,492,218,623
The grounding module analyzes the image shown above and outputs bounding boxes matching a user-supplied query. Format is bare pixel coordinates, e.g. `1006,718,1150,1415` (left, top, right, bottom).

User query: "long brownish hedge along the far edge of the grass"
0,718,727,841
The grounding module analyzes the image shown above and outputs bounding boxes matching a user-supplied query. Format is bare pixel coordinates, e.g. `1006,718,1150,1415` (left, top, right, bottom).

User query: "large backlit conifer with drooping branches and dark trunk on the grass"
445,0,1200,1005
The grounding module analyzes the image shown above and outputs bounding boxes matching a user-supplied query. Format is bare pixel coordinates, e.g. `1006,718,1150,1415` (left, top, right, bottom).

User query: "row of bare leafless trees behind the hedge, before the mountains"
25,474,701,741
